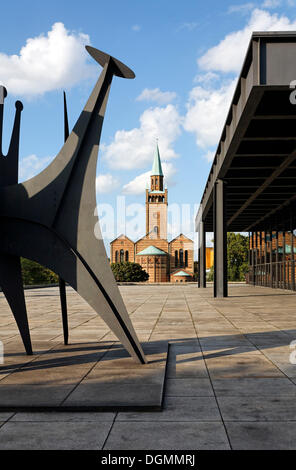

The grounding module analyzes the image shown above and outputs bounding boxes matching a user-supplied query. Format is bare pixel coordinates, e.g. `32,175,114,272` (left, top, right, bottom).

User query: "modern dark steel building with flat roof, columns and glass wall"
196,31,296,297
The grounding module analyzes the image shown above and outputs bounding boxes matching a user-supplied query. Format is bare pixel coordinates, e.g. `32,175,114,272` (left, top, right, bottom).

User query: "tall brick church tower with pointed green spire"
146,143,168,240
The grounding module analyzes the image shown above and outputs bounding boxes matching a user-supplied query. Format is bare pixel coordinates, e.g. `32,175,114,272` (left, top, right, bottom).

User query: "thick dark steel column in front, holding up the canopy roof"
213,180,228,297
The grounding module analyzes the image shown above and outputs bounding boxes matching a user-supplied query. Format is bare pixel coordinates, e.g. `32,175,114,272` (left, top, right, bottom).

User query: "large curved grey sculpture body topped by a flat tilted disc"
0,46,146,363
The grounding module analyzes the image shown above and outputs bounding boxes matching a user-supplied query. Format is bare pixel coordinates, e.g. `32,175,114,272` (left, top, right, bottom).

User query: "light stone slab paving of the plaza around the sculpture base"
0,285,296,450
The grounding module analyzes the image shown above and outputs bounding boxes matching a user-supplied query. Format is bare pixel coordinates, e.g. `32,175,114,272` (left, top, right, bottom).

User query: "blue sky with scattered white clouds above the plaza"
0,0,296,255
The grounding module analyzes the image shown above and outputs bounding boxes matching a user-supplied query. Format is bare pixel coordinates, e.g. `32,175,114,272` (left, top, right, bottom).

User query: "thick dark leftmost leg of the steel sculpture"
0,253,33,355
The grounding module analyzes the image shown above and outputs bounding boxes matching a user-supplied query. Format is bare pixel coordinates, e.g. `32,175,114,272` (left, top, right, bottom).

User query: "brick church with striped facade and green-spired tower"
110,144,194,283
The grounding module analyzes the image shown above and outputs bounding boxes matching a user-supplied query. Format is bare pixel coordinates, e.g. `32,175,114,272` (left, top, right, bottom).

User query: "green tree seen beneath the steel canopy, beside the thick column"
207,232,249,281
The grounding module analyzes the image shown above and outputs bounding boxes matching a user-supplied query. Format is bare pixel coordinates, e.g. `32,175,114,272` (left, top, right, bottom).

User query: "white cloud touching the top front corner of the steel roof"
198,8,296,73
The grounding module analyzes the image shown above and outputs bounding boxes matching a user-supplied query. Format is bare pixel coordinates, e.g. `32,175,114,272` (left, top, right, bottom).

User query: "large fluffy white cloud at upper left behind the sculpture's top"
0,23,94,96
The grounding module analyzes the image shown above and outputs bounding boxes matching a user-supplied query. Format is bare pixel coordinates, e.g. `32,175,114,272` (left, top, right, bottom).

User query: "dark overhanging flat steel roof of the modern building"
196,31,296,232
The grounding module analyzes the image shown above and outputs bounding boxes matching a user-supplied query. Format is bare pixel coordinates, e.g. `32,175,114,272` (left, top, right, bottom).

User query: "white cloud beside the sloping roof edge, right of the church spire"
184,79,236,148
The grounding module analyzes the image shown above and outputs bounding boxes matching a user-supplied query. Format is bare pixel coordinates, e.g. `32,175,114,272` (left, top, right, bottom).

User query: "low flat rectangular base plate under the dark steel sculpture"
0,341,168,411
